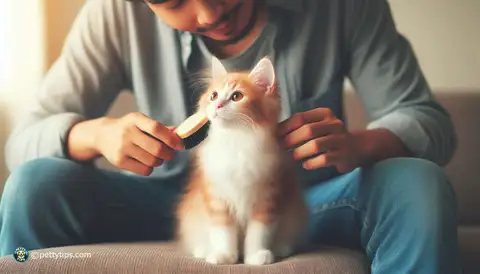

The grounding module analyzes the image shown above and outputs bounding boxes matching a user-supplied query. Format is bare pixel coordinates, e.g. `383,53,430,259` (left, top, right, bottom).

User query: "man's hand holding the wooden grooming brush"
95,113,183,176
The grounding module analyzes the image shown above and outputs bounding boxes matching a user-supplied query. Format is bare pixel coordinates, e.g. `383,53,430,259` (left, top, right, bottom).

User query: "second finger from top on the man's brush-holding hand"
132,130,175,161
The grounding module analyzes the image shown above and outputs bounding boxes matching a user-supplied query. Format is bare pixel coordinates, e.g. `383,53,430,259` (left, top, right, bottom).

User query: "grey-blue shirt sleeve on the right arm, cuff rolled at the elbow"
347,0,457,165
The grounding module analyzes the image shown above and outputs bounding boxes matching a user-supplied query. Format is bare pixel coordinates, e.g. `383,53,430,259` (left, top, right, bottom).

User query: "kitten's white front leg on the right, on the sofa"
245,217,276,265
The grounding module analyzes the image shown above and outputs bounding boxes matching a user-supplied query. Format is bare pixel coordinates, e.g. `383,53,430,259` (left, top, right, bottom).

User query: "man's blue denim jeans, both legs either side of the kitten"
0,158,460,274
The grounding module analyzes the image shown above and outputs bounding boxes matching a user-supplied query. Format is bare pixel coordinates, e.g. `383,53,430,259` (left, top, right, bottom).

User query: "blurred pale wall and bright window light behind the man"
0,0,480,193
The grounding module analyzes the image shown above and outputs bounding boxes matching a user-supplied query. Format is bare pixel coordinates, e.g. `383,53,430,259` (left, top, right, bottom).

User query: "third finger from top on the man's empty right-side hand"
293,135,342,160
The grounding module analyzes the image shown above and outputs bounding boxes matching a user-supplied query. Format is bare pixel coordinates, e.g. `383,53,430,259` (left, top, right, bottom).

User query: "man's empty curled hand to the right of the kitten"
279,108,362,173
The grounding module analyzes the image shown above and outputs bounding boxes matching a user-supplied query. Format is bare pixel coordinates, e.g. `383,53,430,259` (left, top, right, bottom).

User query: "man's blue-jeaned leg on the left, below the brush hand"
0,158,181,255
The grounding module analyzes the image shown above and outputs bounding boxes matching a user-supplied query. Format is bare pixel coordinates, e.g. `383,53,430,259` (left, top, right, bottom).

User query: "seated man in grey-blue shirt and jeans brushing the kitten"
0,0,460,274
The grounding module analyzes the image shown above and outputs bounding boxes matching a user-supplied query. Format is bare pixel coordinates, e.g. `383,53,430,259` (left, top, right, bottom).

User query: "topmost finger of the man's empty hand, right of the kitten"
278,108,334,136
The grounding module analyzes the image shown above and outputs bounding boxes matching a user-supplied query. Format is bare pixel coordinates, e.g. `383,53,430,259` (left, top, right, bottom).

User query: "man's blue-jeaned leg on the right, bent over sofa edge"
305,158,460,273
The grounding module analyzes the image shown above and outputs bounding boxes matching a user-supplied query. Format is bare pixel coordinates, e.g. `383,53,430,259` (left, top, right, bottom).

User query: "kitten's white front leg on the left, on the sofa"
206,199,238,264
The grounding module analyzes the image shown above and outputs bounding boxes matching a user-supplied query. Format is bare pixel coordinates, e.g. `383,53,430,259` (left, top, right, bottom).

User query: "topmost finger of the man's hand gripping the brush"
128,113,183,150
